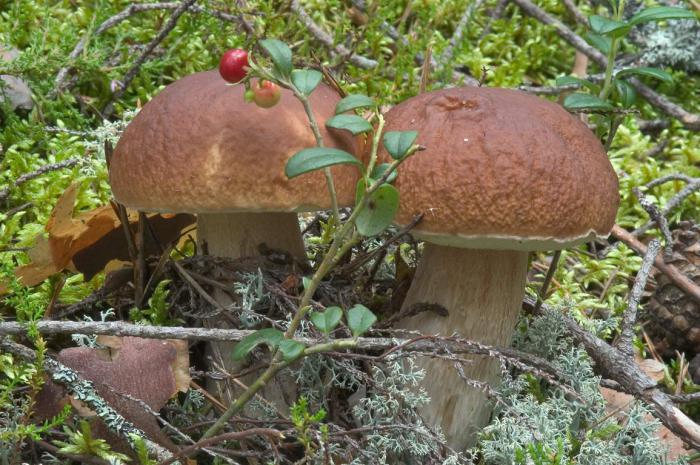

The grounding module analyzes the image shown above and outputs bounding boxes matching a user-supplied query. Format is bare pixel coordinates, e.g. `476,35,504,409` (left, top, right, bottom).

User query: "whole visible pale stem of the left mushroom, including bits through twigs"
197,213,306,408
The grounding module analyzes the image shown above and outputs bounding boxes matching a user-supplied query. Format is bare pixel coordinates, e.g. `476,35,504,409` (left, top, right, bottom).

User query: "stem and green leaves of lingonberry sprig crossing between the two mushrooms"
203,39,420,438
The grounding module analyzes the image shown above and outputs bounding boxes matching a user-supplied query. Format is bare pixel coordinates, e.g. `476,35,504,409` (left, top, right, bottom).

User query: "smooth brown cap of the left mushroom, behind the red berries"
109,70,359,213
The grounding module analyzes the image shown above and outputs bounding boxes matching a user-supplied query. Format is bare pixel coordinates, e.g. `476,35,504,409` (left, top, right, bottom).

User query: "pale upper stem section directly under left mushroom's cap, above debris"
197,213,306,262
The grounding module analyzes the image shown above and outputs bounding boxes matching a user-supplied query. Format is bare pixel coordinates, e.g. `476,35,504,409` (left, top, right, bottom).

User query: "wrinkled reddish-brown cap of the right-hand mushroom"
383,87,620,250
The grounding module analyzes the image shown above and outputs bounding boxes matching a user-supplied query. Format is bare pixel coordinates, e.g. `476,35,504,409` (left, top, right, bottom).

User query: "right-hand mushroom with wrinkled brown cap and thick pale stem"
386,87,619,449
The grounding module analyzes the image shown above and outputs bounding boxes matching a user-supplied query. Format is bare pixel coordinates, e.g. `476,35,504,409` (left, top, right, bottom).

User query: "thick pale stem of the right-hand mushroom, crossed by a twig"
398,242,528,450
